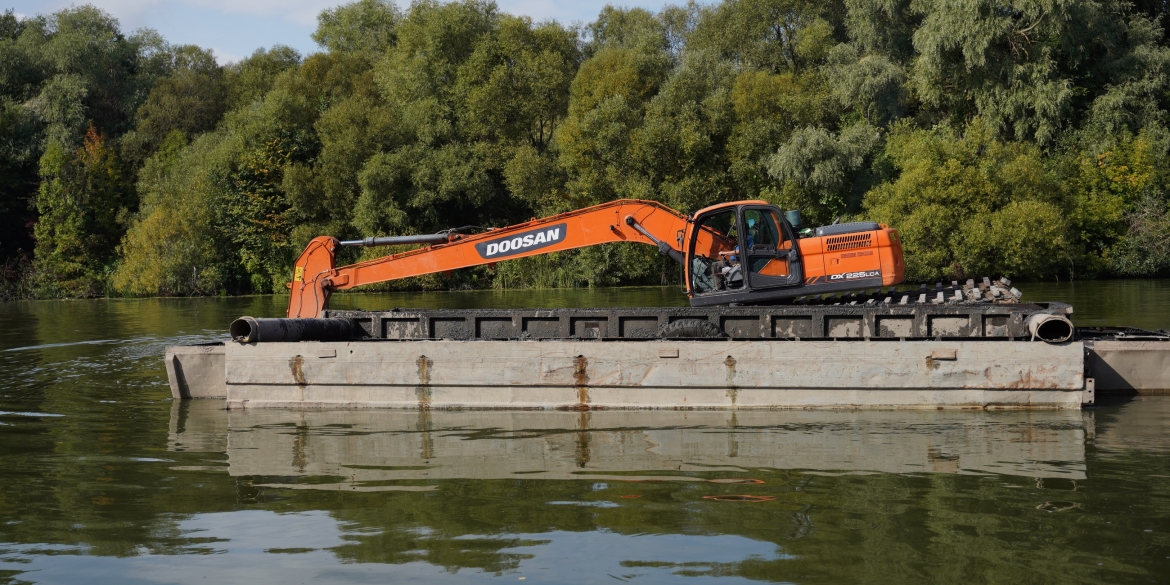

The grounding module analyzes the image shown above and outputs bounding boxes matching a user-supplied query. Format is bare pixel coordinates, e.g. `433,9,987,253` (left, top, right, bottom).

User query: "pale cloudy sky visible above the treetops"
0,0,680,63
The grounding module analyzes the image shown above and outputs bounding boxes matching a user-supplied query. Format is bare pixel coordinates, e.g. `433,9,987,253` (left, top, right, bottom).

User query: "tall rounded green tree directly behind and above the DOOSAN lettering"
353,2,578,233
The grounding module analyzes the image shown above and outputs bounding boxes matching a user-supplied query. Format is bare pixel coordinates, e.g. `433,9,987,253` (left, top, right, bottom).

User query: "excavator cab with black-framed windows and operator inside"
686,201,804,307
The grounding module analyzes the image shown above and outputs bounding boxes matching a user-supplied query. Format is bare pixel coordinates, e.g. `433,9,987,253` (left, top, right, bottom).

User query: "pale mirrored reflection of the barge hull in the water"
170,400,1093,482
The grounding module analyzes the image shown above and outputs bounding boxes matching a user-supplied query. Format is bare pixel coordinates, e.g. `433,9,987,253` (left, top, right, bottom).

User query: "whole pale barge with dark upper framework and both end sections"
166,303,1170,411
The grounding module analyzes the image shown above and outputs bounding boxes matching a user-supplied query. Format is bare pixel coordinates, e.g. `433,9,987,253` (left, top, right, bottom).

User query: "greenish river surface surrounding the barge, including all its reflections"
0,281,1170,584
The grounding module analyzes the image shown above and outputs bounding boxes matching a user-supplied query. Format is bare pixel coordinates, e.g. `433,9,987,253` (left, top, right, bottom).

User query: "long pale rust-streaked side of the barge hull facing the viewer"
215,339,1086,410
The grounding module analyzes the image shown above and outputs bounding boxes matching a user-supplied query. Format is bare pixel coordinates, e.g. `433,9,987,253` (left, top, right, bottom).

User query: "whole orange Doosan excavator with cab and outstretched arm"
288,199,906,318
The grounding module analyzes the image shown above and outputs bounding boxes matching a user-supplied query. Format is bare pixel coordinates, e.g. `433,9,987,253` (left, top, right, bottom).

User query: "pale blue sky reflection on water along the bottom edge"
0,510,787,585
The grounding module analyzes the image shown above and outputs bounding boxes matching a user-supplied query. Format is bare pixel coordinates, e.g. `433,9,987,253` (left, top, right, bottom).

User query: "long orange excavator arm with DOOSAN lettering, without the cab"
288,199,687,318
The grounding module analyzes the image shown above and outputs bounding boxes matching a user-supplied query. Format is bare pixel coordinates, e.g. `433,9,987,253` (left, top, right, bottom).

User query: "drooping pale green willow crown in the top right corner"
910,0,1170,147
